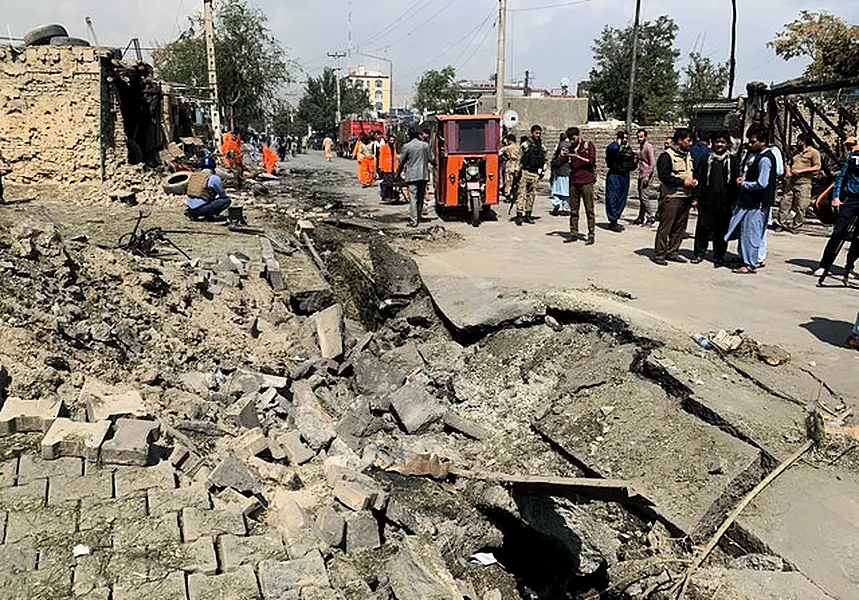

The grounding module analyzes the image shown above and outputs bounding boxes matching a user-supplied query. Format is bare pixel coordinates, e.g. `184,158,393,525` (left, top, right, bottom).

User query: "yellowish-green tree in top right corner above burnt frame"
769,10,859,82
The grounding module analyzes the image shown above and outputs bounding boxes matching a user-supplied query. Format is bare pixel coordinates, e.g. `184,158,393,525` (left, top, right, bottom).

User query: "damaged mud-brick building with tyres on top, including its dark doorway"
0,46,164,184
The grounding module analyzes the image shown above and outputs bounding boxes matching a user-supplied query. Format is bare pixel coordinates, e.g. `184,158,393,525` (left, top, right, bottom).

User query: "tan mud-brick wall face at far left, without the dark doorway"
0,46,125,183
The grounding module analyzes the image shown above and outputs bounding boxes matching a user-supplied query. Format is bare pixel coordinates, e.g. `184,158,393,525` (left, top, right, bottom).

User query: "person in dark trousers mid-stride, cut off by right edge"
814,138,859,282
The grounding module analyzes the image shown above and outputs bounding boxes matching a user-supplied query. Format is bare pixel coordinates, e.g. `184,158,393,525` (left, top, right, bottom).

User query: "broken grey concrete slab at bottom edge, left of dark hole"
386,536,464,600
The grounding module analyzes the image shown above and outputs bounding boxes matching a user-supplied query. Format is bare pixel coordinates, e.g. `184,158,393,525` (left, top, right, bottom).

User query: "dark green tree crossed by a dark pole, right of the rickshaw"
590,15,680,124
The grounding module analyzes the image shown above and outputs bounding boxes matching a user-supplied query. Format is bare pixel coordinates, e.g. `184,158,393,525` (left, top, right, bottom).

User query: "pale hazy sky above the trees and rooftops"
0,0,859,103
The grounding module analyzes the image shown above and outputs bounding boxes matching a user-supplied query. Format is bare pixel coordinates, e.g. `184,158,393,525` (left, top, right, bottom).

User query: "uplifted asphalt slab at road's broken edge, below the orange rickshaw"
423,275,546,335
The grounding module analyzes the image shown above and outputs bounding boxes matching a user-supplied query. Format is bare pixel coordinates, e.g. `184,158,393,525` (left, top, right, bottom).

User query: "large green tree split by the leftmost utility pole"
153,0,292,127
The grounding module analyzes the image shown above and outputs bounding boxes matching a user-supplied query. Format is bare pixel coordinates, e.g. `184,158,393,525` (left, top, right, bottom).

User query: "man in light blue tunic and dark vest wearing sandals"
725,127,777,275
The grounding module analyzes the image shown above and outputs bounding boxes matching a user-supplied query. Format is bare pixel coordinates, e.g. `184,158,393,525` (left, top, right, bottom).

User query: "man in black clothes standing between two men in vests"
692,130,740,267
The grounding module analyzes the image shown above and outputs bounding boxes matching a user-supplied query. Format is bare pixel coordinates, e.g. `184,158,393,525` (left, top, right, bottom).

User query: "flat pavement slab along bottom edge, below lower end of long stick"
689,569,836,600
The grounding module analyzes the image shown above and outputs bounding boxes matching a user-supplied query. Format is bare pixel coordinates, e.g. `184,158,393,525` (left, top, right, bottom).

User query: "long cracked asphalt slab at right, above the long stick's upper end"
644,347,806,463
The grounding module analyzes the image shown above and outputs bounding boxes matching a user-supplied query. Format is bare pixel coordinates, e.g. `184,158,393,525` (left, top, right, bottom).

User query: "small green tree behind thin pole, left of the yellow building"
297,68,372,134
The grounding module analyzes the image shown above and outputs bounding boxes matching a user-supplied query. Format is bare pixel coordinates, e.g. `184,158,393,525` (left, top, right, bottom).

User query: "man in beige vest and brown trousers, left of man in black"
651,128,698,266
